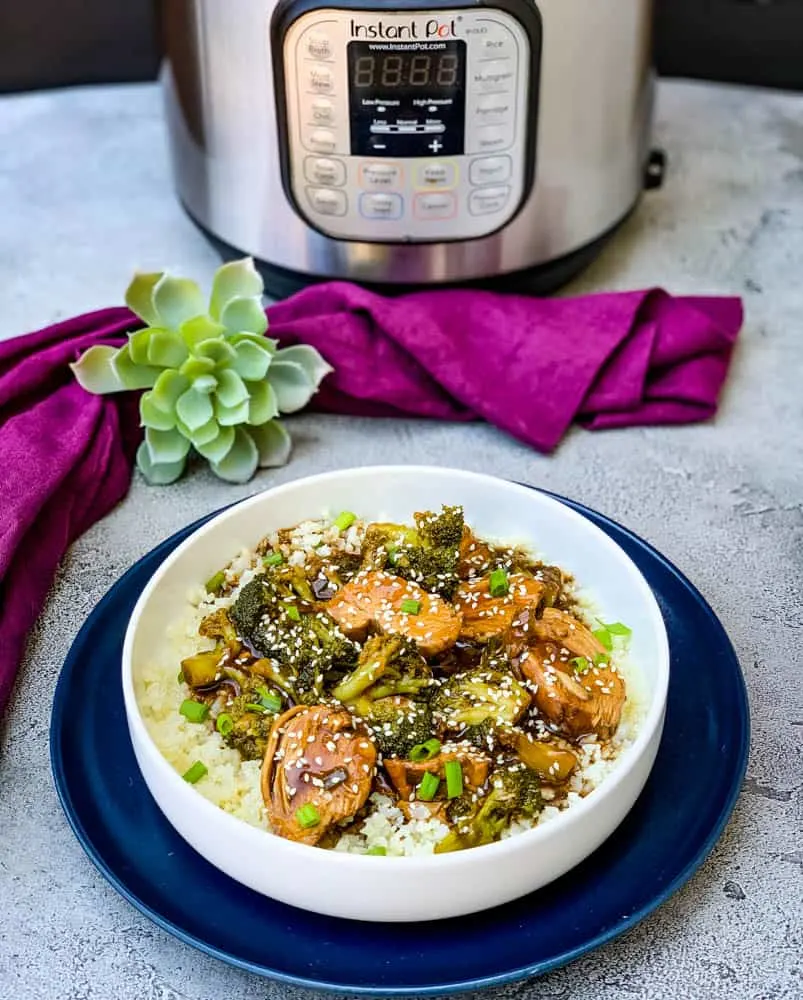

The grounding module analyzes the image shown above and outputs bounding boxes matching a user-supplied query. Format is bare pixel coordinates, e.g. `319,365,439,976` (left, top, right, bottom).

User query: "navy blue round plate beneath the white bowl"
51,488,749,996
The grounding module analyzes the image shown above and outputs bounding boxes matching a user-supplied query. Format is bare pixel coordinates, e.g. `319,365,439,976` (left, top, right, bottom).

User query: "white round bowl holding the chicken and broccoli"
123,466,669,921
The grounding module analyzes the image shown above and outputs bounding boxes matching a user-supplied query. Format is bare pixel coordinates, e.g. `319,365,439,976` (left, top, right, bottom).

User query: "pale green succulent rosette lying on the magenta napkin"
71,258,332,485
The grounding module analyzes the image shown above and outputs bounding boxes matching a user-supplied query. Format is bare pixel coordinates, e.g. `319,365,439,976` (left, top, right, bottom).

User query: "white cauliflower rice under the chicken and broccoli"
135,517,646,857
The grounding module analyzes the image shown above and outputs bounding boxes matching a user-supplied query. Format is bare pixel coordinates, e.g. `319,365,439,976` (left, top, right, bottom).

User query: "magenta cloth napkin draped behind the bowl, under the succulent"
0,282,743,712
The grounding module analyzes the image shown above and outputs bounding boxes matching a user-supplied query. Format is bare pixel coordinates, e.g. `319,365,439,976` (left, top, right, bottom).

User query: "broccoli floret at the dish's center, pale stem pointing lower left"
332,635,432,705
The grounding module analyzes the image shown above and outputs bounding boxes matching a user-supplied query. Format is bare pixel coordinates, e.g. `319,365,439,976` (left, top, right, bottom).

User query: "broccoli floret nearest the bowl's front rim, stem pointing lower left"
435,761,543,854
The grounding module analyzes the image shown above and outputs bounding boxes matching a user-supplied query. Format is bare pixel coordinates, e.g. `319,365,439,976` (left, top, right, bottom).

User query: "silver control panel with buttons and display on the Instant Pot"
280,6,535,243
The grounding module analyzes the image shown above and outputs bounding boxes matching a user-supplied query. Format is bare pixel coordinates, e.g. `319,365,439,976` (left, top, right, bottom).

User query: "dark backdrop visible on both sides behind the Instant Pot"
0,0,803,92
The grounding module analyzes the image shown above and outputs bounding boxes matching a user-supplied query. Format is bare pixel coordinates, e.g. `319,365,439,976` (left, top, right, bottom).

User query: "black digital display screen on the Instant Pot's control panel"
348,39,466,157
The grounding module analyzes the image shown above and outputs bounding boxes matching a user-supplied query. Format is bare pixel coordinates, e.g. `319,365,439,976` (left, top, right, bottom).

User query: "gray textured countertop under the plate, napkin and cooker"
0,83,803,1000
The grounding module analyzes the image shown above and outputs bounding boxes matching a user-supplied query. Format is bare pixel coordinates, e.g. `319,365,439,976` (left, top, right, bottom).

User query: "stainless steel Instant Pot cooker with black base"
162,0,660,297
